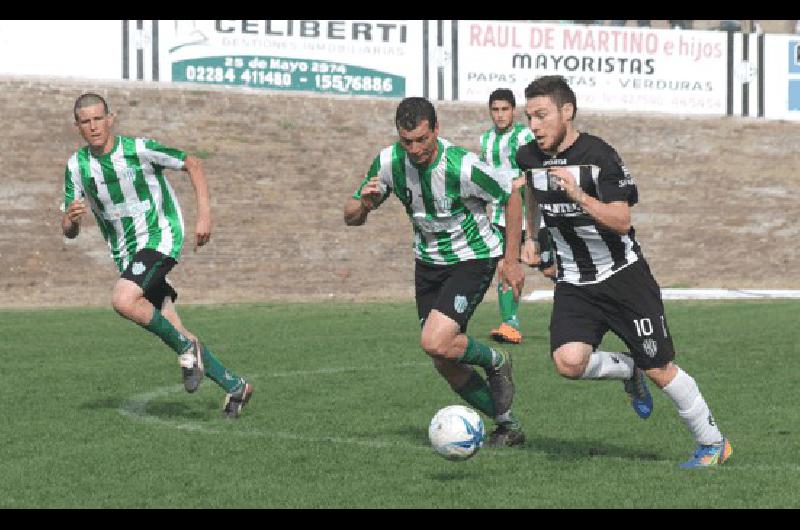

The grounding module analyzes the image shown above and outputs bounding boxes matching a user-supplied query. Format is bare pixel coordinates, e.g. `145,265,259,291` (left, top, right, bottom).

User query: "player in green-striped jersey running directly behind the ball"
344,97,525,447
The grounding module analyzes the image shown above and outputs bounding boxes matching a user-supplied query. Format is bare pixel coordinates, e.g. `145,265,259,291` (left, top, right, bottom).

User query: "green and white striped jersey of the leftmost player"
62,136,186,272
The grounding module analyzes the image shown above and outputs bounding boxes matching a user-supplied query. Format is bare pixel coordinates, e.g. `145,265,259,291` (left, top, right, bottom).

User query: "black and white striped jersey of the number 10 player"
517,133,644,285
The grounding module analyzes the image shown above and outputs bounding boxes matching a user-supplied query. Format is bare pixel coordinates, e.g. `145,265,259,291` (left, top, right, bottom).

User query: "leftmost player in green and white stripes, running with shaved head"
61,94,253,418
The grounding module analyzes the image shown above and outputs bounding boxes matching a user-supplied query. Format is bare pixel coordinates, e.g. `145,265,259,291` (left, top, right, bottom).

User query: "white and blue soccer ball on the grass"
428,405,486,460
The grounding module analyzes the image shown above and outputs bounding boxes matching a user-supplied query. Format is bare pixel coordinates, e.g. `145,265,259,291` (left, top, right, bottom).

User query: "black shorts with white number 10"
550,259,675,369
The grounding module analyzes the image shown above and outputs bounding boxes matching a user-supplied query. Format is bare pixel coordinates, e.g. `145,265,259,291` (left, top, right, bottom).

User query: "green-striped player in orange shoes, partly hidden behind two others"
481,88,535,344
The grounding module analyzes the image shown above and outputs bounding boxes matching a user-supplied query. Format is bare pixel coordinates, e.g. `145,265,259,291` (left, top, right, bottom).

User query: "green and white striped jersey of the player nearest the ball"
353,138,519,265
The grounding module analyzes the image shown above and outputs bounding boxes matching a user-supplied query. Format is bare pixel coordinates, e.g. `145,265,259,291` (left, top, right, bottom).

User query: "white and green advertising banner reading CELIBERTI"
159,20,423,97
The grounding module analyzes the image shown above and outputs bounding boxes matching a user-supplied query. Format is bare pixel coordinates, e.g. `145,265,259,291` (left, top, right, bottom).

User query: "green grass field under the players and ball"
0,301,800,508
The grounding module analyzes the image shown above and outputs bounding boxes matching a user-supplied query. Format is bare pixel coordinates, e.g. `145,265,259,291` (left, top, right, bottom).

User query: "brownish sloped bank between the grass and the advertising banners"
0,73,800,307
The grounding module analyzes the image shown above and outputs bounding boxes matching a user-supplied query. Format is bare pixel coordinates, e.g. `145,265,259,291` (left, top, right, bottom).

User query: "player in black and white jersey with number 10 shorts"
514,76,732,467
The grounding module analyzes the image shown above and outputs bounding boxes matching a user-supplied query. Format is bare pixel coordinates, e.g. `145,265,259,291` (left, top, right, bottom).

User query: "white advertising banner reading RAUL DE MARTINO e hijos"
458,20,727,115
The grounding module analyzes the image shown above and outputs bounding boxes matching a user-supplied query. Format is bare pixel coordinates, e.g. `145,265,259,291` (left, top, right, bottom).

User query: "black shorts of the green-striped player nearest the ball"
414,258,498,333
